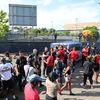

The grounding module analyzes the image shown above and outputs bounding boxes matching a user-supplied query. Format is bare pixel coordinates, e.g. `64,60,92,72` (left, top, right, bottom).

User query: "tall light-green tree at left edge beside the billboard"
0,10,9,40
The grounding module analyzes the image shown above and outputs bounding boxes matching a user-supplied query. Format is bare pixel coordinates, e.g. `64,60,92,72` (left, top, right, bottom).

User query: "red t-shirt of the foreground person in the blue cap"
24,83,40,100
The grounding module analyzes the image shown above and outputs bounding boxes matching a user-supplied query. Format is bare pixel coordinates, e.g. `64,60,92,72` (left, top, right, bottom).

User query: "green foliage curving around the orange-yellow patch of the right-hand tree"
83,26,99,41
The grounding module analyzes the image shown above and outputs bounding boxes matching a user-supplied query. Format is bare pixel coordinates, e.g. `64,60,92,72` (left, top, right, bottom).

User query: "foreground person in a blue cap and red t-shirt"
24,74,42,100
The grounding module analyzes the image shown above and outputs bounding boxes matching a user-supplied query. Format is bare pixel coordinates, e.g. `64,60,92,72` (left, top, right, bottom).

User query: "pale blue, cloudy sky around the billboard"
0,0,100,30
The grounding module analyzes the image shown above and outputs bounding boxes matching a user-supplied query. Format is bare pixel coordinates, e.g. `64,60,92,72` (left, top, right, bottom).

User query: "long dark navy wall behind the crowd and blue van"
0,42,100,53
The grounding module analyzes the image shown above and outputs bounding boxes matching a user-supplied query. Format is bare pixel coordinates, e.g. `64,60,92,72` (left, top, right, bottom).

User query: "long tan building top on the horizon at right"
64,22,100,30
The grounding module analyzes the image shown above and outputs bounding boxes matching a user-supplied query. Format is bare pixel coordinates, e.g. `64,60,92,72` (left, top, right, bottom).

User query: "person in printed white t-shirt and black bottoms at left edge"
0,58,17,100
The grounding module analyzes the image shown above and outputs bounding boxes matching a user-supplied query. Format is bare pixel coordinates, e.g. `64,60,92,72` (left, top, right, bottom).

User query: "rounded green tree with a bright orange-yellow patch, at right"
82,26,99,41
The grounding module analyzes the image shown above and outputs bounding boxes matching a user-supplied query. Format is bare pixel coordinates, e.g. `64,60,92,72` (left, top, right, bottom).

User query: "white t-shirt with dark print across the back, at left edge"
0,63,13,81
